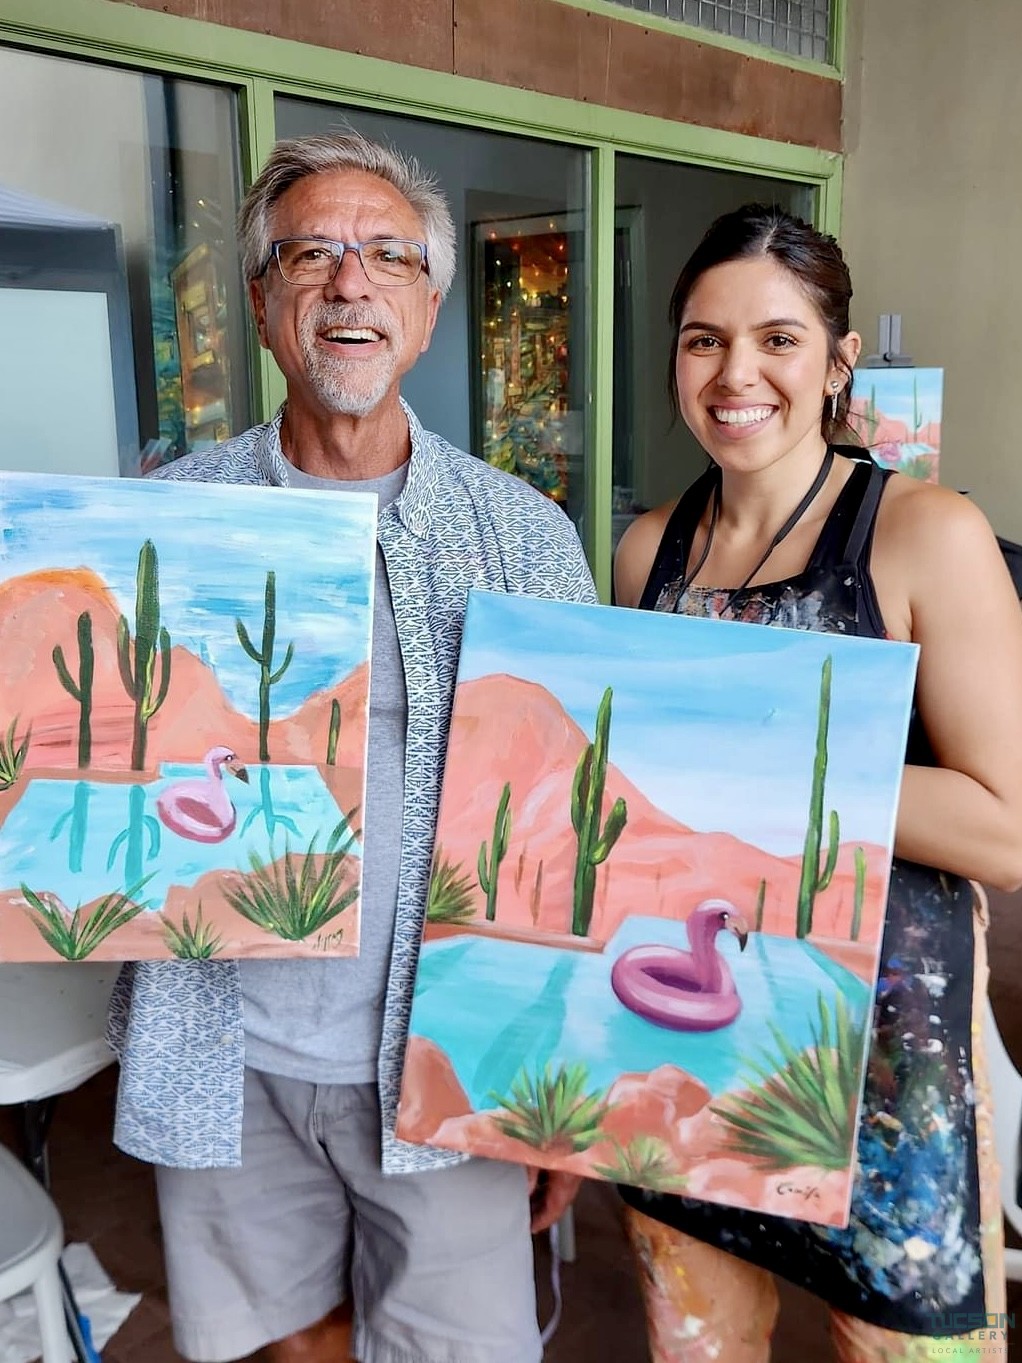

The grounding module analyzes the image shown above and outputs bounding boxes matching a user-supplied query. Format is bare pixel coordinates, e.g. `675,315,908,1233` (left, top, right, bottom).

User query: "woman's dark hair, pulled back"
668,203,852,443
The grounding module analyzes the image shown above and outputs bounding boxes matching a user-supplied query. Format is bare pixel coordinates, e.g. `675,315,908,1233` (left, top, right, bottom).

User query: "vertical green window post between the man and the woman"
586,147,616,602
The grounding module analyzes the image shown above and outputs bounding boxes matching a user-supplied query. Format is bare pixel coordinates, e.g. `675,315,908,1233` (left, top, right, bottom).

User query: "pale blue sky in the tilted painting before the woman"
458,592,918,856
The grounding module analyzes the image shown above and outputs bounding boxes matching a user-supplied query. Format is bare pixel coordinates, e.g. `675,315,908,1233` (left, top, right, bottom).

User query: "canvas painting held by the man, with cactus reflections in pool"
0,473,376,961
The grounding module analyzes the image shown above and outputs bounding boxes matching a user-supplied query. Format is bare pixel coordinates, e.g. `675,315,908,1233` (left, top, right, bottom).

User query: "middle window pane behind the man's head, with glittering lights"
277,98,587,525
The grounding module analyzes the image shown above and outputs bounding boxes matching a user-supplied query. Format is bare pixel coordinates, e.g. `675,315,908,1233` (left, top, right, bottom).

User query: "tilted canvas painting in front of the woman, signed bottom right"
398,592,917,1225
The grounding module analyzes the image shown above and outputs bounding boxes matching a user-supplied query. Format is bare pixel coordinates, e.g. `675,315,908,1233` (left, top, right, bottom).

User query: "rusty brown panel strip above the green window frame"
104,0,841,151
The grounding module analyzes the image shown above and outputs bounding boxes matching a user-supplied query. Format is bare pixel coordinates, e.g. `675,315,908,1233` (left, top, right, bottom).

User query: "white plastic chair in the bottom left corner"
0,1145,71,1363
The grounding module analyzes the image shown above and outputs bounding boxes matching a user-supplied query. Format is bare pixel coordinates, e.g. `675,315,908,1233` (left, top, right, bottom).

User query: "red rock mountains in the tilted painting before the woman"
437,675,888,945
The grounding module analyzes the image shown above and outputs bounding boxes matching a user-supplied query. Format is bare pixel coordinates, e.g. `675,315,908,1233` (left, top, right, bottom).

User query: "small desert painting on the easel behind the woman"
849,368,944,483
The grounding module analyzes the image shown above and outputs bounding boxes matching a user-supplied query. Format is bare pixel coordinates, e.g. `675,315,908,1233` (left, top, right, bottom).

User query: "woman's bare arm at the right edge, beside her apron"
872,478,1022,890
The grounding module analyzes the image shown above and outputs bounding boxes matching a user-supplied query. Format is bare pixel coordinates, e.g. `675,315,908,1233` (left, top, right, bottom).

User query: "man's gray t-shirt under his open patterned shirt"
240,463,407,1084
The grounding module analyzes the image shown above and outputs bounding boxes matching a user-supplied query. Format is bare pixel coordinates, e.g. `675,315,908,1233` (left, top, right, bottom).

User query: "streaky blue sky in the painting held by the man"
0,474,376,718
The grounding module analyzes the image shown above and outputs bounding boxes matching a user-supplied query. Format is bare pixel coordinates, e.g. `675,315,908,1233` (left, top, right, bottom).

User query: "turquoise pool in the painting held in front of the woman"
412,917,871,1108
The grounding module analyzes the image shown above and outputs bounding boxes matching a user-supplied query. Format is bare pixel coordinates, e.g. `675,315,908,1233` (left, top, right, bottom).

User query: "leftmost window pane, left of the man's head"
0,49,251,474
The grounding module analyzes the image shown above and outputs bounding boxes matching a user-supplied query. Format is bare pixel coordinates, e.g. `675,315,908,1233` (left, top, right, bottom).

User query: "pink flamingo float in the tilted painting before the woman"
610,900,748,1032
